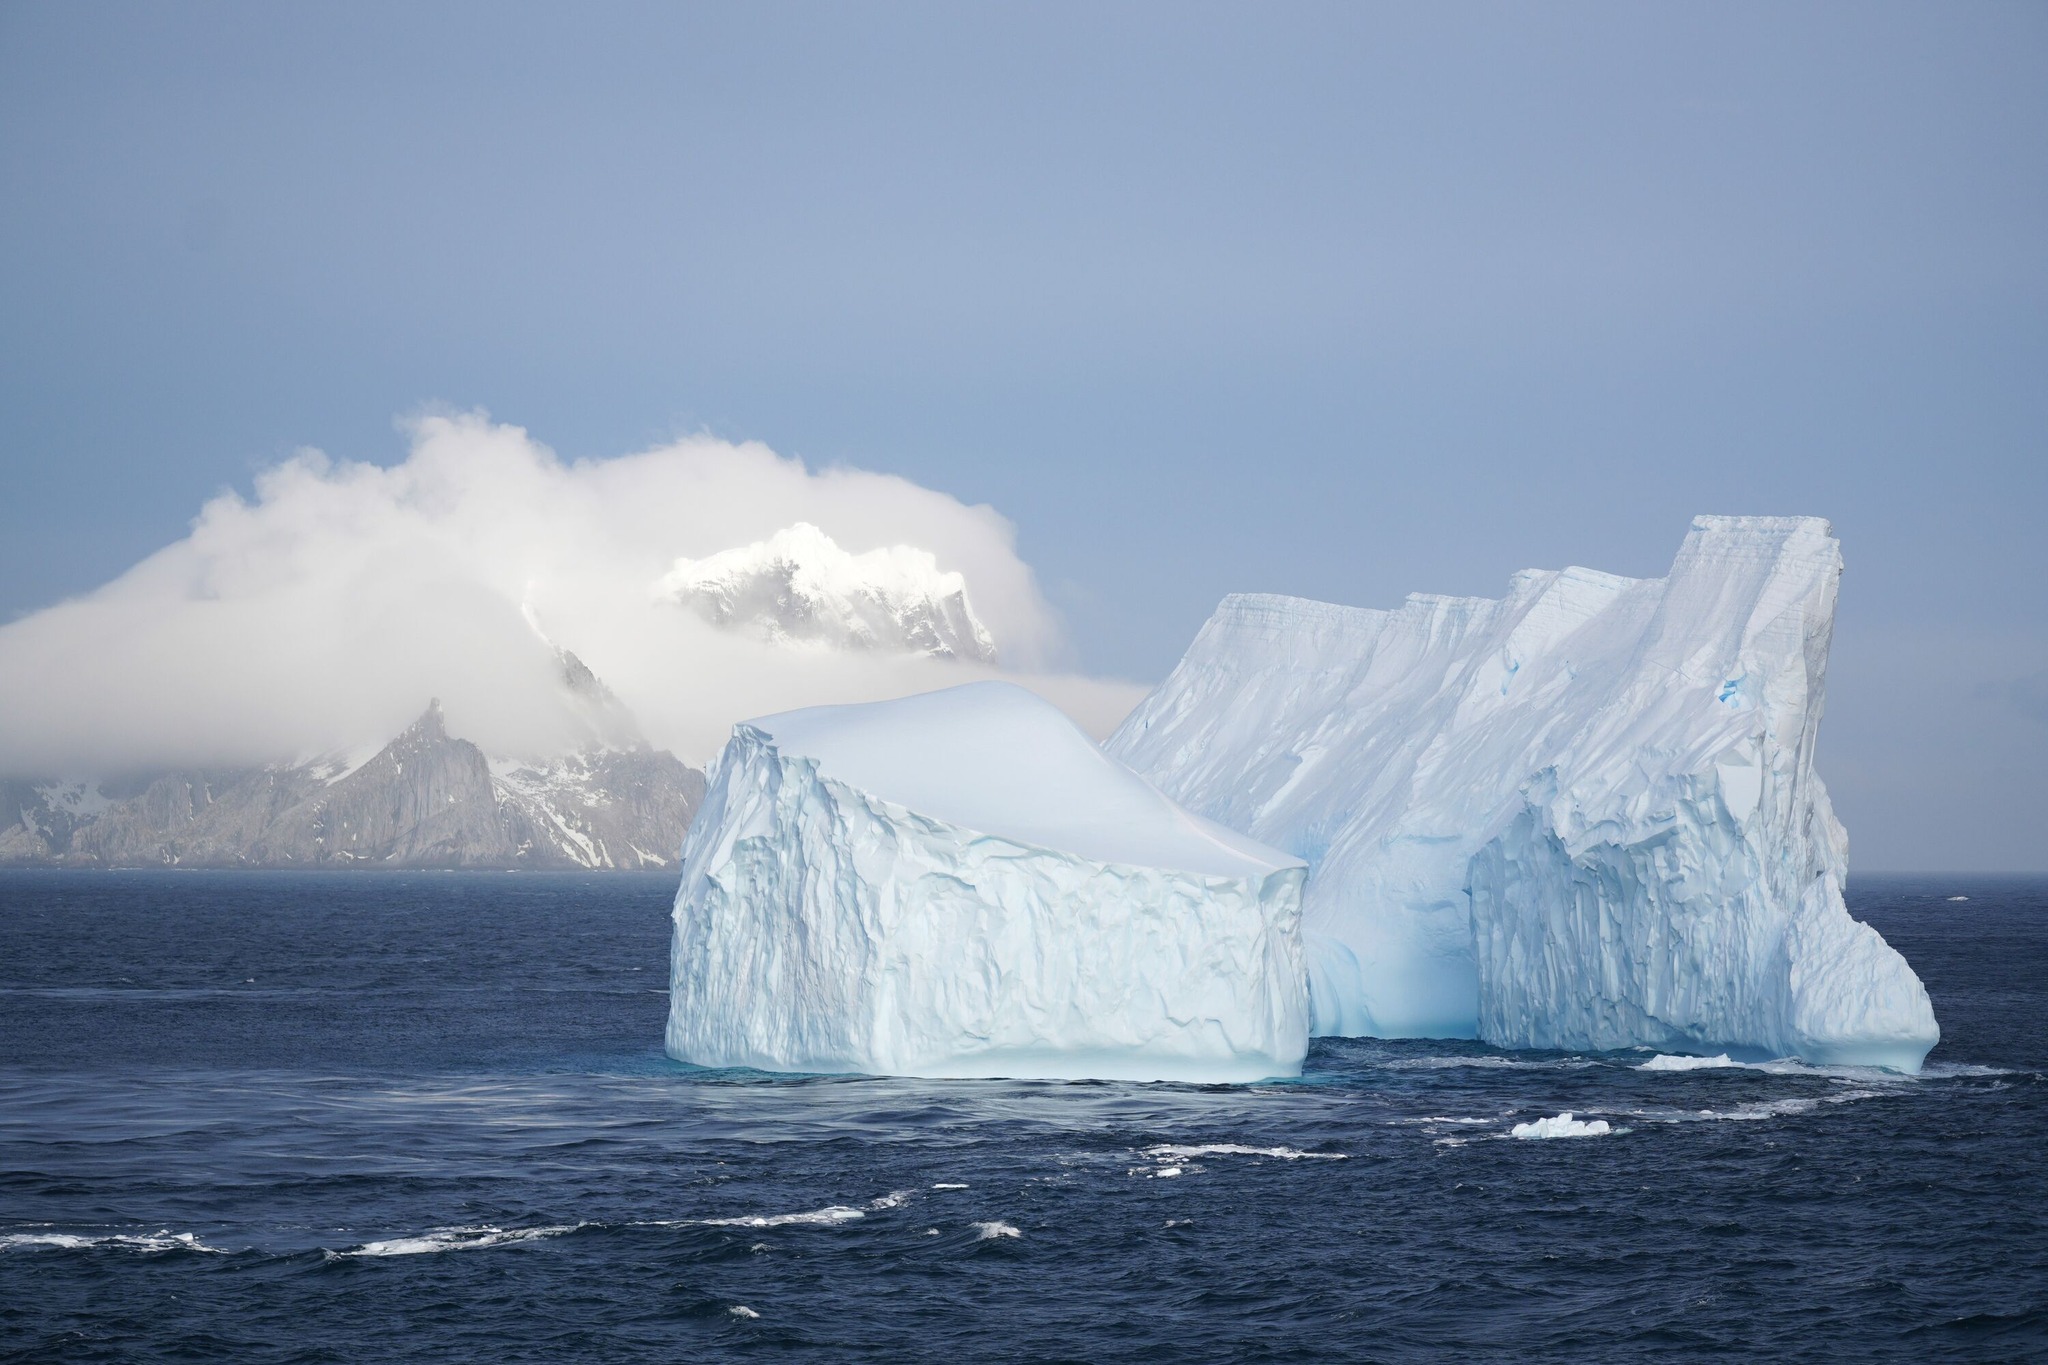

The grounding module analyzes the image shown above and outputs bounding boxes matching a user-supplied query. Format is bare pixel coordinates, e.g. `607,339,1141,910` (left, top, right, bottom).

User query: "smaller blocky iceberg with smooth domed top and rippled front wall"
668,681,1309,1081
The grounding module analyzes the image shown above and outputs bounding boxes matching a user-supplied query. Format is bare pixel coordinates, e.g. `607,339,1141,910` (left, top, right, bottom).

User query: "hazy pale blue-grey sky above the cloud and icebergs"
0,2,2048,870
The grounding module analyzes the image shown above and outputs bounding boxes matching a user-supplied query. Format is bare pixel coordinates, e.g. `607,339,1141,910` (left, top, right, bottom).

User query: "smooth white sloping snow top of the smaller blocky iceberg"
748,681,1303,876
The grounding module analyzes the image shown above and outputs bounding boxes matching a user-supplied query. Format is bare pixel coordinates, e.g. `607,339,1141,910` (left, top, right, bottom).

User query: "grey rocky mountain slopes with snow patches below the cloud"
0,699,705,868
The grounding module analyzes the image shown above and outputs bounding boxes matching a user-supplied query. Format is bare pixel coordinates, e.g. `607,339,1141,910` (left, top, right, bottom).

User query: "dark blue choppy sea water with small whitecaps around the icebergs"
0,872,2048,1361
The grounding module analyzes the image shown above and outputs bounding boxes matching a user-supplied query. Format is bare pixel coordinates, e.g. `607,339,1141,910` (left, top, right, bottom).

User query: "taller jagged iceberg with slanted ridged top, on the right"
1108,518,1939,1070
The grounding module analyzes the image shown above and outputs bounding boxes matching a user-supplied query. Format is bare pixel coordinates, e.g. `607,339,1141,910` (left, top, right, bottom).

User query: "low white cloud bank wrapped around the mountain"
0,415,1143,776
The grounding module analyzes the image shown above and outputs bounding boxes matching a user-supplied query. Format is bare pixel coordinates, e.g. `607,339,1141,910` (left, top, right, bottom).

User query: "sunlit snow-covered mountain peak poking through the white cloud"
655,522,995,663
